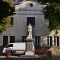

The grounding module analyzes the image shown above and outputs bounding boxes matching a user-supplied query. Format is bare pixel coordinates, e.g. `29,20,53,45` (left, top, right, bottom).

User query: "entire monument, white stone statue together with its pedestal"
25,23,35,56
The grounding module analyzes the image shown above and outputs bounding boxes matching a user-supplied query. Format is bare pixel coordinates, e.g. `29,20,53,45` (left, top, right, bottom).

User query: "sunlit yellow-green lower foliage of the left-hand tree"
0,16,10,33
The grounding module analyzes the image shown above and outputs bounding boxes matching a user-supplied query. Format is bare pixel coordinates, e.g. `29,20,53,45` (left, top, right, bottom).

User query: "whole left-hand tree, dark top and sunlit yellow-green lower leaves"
0,0,14,33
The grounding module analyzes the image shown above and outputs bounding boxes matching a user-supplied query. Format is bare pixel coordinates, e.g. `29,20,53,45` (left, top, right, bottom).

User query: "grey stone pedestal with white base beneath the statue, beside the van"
25,39,35,55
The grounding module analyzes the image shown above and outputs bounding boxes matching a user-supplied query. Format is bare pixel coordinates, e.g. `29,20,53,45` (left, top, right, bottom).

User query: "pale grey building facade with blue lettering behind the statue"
0,1,60,46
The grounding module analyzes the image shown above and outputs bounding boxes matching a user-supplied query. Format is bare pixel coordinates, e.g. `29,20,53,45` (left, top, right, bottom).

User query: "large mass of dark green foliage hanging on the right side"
44,3,60,30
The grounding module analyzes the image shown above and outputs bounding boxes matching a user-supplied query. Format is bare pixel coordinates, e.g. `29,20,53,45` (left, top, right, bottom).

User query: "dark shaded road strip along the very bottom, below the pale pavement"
0,57,60,60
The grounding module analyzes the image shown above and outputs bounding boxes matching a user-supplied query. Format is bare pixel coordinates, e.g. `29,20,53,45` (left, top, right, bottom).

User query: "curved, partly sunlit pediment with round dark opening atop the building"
15,1,42,11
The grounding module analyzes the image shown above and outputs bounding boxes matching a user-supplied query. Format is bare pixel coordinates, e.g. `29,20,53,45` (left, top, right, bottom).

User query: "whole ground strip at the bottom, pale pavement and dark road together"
0,56,60,60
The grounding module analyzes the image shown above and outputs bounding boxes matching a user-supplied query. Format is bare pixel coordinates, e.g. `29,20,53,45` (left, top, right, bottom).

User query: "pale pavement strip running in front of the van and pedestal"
0,55,50,58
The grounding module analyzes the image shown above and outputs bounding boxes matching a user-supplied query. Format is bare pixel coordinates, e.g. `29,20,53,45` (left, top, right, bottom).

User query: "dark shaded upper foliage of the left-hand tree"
0,0,13,19
